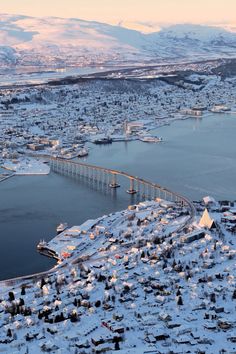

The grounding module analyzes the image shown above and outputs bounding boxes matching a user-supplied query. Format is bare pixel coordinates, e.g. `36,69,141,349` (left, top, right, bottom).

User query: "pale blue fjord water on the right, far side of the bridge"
87,113,236,200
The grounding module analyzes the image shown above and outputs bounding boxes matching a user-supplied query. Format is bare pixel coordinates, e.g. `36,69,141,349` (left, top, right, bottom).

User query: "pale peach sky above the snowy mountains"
0,0,236,23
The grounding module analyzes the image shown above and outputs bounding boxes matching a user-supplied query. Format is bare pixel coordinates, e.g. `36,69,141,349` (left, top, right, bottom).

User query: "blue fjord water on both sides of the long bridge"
0,114,236,279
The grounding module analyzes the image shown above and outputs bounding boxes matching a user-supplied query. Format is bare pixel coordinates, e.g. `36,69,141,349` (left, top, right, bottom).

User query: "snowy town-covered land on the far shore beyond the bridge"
0,69,236,163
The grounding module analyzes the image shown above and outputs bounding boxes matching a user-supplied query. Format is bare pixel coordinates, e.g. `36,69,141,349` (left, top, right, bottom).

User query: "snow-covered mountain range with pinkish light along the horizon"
0,14,236,66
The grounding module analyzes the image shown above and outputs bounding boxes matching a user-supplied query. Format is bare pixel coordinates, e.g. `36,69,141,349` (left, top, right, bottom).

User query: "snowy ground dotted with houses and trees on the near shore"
0,200,236,354
